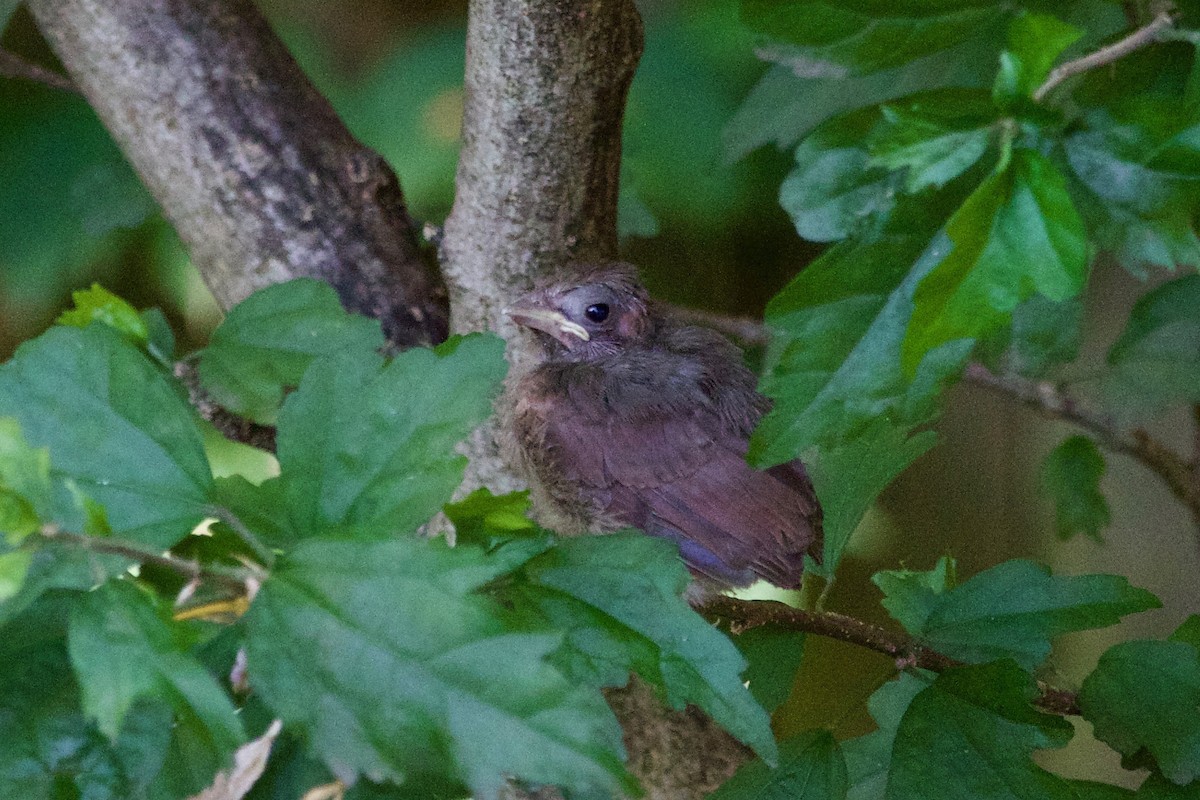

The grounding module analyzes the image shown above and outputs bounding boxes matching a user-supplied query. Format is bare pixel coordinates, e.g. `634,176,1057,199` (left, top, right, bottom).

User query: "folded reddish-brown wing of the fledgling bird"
544,367,821,587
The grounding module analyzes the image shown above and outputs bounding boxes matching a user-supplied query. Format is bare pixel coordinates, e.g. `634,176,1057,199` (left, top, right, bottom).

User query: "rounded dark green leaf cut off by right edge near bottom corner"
1079,642,1200,784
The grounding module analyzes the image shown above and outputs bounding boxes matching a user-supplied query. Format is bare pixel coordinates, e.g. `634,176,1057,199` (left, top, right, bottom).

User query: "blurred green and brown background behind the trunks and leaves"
0,0,1200,780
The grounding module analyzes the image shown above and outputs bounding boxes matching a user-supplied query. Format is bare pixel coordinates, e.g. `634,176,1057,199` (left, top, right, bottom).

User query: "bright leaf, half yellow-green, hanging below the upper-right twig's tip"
902,149,1087,374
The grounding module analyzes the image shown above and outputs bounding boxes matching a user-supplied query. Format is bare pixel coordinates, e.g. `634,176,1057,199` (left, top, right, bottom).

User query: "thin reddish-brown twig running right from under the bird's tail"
700,595,1080,716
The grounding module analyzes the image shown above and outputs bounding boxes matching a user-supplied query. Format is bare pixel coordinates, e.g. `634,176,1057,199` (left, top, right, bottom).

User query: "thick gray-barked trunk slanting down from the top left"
29,0,448,345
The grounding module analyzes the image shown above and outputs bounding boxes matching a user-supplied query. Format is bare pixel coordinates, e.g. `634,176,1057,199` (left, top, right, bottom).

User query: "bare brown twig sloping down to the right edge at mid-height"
964,363,1200,523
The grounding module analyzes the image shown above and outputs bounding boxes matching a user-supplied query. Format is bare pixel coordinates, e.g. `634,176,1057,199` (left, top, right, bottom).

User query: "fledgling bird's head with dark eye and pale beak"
504,263,654,361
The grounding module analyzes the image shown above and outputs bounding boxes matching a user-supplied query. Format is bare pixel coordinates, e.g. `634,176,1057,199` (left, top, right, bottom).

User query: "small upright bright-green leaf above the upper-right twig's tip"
992,12,1084,107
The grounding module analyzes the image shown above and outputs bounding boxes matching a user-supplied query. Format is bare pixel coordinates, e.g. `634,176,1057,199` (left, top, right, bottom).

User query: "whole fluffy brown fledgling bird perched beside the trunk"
506,263,822,588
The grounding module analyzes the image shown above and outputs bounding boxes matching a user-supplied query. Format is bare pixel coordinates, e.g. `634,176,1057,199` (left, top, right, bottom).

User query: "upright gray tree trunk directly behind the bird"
442,0,749,800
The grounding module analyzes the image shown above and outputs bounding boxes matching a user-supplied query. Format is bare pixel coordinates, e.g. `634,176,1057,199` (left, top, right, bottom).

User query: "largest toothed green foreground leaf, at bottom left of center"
244,537,632,796
